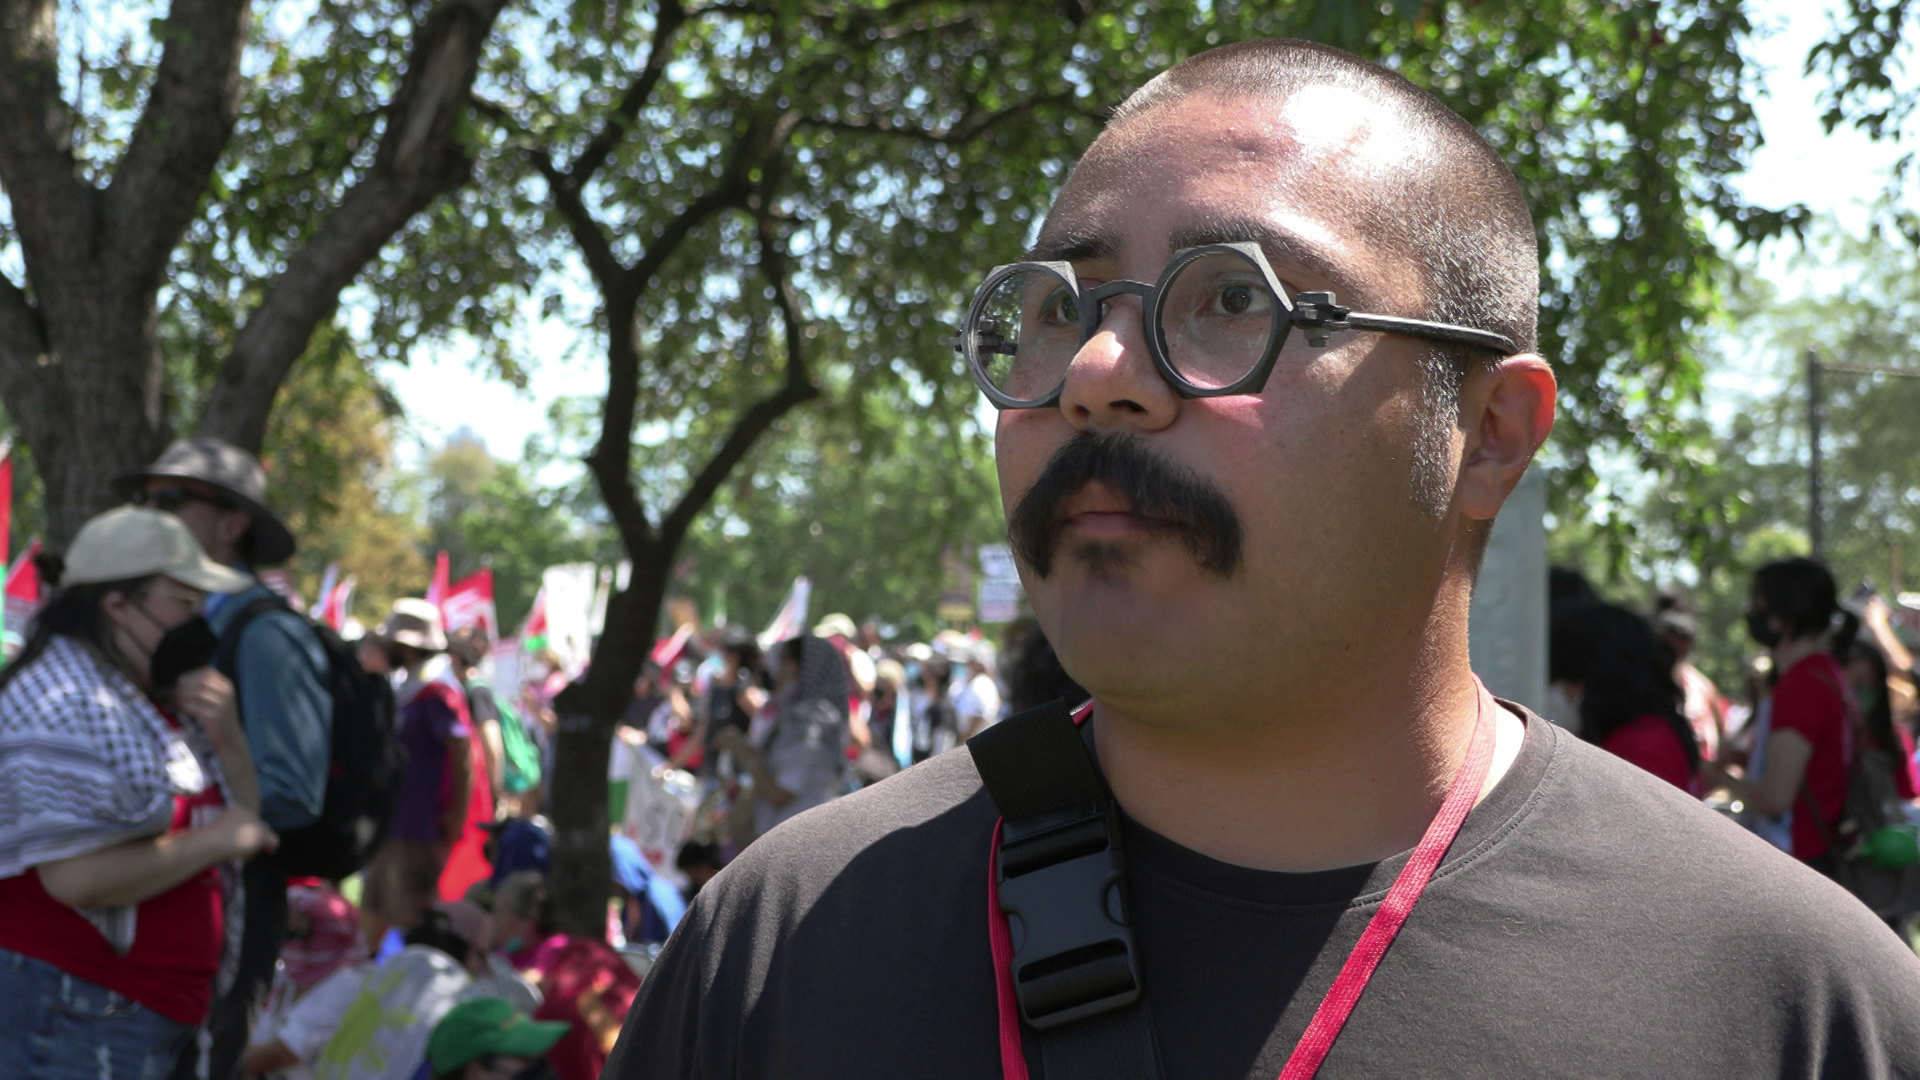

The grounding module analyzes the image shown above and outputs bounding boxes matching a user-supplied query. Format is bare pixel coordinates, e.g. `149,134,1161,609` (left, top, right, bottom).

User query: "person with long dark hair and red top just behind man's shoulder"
1548,603,1701,796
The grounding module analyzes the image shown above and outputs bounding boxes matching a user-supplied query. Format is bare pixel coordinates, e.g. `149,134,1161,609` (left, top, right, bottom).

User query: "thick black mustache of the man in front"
1006,430,1240,578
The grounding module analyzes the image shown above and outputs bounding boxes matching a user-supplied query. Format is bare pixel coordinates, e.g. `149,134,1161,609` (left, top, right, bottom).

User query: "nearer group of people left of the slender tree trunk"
0,432,648,1080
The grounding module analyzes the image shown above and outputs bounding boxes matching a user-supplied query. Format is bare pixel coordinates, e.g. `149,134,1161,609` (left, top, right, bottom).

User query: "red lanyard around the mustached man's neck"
987,690,1494,1080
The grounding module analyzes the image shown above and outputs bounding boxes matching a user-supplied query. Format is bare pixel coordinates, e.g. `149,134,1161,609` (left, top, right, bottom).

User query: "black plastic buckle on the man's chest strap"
996,807,1140,1030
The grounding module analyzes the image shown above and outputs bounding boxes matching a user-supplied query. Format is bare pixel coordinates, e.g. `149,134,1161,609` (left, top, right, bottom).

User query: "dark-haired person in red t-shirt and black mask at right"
1711,559,1853,864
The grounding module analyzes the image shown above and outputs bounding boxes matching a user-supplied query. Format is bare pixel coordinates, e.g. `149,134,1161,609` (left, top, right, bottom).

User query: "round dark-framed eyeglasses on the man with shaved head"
954,242,1519,409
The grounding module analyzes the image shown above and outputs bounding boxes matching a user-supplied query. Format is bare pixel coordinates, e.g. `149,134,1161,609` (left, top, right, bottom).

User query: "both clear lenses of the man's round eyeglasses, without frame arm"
970,252,1284,400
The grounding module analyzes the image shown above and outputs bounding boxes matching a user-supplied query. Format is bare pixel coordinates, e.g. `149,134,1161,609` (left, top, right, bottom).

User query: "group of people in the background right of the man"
1548,557,1920,899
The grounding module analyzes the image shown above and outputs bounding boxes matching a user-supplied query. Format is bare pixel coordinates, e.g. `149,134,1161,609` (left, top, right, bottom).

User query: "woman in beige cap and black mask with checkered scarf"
0,507,275,1080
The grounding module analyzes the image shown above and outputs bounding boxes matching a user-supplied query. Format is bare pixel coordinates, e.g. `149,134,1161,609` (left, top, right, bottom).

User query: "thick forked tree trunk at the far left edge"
0,0,250,548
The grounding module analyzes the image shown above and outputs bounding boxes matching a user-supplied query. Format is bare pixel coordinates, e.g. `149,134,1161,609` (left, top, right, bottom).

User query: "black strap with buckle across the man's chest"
966,701,1160,1080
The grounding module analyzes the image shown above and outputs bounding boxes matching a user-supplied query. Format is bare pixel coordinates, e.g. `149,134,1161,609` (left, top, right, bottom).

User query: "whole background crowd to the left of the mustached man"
0,430,1079,1080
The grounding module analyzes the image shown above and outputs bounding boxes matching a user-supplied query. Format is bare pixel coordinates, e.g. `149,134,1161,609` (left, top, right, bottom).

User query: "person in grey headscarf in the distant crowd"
720,638,849,836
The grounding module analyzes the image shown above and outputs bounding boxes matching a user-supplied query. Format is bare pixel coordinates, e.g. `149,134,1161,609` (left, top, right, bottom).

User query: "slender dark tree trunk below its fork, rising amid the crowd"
553,548,674,938
